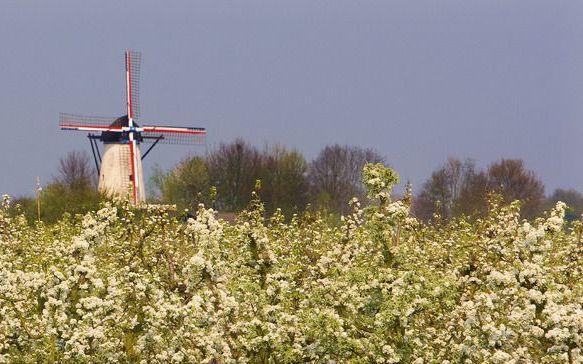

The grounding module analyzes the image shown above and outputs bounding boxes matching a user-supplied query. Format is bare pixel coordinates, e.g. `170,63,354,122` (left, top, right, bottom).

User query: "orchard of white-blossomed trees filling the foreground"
0,164,583,364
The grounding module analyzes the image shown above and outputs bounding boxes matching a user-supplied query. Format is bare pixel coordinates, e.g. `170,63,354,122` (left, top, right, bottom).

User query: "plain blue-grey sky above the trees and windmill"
0,0,583,196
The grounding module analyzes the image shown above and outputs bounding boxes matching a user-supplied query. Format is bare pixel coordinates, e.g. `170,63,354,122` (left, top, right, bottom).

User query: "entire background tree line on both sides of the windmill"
14,139,583,223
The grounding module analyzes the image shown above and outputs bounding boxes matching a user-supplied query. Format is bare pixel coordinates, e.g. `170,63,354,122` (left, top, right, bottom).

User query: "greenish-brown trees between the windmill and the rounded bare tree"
150,140,308,216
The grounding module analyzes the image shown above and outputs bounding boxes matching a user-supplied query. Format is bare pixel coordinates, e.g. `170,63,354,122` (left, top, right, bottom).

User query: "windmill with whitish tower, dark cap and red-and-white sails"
59,51,206,205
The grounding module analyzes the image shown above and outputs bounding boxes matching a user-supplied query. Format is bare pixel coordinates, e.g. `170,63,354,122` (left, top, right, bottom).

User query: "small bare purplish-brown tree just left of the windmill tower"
57,151,96,190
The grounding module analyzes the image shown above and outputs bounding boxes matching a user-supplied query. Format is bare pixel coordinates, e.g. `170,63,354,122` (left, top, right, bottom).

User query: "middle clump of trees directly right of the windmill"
151,139,384,215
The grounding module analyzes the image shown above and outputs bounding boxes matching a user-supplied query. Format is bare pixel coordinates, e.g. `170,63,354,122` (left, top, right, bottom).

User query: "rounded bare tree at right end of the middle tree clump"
308,144,384,213
